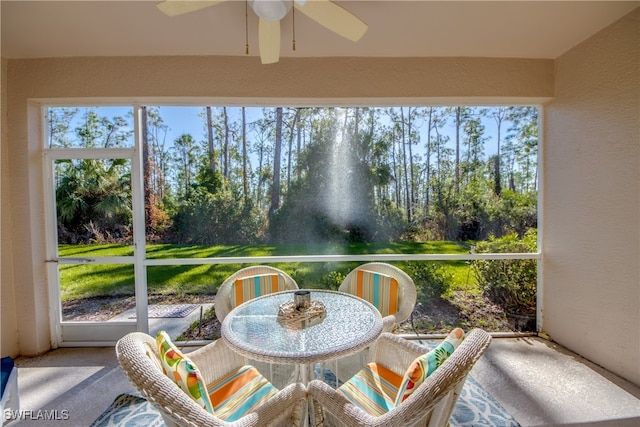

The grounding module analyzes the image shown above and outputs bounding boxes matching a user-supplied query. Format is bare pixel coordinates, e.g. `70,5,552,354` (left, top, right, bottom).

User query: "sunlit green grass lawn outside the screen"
59,241,477,302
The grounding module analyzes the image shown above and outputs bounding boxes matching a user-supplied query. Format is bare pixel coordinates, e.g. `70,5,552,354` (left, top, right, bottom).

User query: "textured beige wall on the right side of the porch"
542,9,640,384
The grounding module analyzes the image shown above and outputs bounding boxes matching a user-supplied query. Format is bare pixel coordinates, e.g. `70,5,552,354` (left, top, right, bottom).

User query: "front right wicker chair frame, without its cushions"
308,329,491,427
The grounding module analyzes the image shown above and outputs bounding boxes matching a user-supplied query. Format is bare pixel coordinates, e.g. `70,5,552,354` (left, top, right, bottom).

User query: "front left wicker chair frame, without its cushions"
116,332,306,427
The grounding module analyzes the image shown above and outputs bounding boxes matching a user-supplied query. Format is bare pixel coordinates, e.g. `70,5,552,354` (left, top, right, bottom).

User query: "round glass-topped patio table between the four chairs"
221,289,382,384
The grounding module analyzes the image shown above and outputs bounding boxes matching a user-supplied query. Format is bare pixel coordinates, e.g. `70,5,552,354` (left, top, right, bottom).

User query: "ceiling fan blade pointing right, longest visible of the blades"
294,0,368,42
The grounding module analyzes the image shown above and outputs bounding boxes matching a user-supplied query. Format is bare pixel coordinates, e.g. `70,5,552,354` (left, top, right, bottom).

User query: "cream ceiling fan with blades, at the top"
157,0,367,64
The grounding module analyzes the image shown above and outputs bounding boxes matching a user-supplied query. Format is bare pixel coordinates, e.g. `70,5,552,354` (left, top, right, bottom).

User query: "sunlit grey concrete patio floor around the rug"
10,337,640,426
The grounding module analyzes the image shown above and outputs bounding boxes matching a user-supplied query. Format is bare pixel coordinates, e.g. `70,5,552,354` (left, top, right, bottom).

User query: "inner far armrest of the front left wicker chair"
187,338,248,384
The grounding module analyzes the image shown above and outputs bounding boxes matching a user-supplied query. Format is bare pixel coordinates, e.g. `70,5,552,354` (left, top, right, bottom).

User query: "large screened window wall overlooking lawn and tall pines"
45,105,539,346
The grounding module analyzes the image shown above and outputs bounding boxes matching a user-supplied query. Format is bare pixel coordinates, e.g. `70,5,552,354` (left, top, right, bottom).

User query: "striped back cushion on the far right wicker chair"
348,270,400,317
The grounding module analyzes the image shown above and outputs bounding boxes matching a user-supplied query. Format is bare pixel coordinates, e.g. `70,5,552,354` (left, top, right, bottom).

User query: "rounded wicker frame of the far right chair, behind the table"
338,262,416,332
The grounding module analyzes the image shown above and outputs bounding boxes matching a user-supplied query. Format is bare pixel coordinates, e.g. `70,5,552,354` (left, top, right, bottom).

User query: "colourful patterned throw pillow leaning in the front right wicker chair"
395,328,464,406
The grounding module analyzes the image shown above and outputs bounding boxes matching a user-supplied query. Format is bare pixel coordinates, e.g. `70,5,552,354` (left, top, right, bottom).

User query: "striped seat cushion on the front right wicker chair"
337,362,402,417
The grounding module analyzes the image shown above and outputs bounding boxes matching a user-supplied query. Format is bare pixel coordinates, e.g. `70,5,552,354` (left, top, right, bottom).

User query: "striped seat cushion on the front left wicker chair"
207,365,278,422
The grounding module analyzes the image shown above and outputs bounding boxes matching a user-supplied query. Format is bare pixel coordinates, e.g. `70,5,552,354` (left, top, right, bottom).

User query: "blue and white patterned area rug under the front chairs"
91,376,520,427
